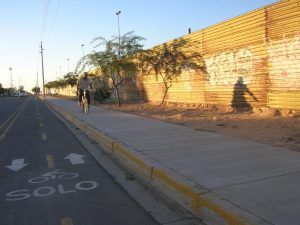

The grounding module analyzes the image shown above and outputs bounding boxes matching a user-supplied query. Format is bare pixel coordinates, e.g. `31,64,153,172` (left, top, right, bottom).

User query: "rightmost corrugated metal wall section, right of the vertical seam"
267,0,300,110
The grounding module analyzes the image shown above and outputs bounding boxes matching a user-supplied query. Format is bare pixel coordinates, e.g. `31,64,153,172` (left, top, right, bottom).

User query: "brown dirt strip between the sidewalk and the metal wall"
97,103,300,152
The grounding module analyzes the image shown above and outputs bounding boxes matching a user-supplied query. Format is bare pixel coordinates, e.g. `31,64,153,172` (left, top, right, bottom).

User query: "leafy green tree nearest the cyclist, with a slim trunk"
81,32,144,106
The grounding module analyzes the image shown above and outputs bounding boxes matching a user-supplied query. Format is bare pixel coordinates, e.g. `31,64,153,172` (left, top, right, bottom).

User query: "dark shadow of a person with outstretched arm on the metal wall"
231,77,258,111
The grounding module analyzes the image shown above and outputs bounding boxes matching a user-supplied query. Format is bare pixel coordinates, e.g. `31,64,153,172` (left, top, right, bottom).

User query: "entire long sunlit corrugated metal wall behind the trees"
123,0,300,110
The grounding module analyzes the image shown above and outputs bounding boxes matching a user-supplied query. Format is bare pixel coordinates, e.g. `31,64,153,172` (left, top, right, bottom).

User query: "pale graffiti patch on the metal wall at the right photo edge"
268,34,300,89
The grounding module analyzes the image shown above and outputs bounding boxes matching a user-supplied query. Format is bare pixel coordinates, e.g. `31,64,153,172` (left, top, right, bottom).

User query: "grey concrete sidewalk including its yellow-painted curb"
46,97,300,225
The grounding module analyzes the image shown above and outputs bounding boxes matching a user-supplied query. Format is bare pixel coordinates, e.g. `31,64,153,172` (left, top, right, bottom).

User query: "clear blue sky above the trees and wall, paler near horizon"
0,0,277,91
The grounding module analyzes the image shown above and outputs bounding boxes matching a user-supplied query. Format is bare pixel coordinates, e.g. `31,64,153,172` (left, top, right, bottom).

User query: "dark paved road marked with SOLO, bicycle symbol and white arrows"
0,97,156,225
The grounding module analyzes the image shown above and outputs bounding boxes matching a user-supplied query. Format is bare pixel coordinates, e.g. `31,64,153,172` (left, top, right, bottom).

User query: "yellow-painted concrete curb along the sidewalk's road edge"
46,102,271,225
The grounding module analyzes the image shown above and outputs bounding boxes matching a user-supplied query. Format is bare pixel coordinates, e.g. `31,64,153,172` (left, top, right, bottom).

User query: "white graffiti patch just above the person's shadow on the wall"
204,48,253,85
